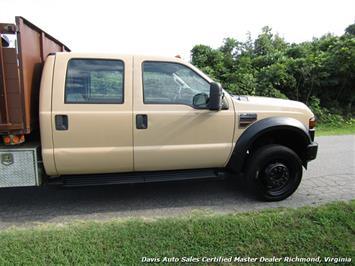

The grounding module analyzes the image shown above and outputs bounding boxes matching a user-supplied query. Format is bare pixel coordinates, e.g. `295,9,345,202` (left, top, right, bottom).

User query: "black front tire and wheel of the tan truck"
246,144,302,201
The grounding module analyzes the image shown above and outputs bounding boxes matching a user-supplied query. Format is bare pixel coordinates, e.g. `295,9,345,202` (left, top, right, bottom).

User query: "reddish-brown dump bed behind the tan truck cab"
0,17,70,135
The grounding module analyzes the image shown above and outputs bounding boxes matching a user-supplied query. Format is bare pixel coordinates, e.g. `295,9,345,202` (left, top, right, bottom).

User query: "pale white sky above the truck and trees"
0,0,355,60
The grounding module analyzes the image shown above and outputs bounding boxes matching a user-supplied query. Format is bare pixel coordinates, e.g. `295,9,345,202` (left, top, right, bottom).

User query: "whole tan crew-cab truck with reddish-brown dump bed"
0,17,317,200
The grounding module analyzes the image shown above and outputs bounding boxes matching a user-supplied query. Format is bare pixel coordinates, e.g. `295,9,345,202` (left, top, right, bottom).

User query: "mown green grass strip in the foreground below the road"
0,201,355,265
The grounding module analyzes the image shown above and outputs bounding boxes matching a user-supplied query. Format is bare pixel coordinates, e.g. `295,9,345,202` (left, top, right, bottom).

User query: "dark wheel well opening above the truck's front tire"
243,129,308,170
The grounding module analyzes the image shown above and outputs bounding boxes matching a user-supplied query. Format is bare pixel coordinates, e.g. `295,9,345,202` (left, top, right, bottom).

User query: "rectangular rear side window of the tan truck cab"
65,59,124,104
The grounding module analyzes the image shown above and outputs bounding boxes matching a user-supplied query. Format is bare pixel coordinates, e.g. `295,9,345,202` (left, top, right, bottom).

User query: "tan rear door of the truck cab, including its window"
52,54,133,175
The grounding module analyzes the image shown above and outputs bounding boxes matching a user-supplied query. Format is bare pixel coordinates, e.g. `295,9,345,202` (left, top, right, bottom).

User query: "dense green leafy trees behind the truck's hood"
191,24,355,118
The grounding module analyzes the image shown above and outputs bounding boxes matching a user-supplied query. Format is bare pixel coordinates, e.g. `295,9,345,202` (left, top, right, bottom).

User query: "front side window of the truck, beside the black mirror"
143,62,210,105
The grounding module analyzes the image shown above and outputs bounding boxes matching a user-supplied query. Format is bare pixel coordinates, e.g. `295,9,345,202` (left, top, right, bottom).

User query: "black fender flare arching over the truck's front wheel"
227,117,312,174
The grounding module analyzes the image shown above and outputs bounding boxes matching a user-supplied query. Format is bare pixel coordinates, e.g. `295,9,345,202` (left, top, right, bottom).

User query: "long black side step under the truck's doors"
62,169,226,187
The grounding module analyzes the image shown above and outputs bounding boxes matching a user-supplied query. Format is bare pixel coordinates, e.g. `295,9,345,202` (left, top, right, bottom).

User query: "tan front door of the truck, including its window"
134,57,235,171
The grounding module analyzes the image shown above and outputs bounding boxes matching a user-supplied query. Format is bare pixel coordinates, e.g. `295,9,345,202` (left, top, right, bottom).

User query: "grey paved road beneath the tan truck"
0,135,355,228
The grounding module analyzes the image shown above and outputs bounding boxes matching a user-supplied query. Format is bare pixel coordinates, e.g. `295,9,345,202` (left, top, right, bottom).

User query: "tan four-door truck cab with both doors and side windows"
40,53,235,175
